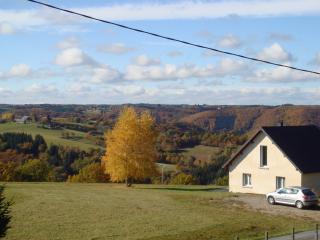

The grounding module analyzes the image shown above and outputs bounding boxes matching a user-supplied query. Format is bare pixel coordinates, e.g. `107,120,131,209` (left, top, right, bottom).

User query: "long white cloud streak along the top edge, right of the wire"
71,0,320,21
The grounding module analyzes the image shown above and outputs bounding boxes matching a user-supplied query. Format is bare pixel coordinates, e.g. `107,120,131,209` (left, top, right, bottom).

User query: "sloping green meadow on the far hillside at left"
0,122,100,150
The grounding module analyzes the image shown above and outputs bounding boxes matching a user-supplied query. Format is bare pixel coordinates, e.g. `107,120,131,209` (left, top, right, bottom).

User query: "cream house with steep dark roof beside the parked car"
223,125,320,194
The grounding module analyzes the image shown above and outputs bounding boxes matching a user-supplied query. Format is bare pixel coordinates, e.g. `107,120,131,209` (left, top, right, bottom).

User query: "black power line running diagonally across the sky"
27,0,320,75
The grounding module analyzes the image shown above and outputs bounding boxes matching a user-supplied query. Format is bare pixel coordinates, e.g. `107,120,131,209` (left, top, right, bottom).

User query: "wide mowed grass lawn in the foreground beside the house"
1,183,312,240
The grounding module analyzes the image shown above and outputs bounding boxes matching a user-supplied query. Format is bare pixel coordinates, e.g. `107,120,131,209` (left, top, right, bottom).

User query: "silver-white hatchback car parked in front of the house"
266,187,318,209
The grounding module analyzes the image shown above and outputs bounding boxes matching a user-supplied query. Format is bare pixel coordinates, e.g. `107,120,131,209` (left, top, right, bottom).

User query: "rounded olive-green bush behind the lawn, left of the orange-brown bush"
19,159,50,182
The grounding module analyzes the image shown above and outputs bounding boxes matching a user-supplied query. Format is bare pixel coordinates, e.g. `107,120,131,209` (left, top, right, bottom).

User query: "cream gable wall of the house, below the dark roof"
229,132,302,194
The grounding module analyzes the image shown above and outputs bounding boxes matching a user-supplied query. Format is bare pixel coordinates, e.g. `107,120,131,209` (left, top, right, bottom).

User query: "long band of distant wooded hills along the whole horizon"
0,104,320,133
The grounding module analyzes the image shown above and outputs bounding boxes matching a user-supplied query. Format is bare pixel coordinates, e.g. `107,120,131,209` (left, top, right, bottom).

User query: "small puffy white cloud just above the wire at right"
258,43,292,62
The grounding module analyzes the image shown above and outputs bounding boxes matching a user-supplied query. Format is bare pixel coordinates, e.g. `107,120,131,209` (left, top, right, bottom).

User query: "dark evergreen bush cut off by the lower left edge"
0,186,12,238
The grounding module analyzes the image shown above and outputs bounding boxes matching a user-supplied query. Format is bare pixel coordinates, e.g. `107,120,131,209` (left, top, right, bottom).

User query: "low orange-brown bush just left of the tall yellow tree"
68,163,108,183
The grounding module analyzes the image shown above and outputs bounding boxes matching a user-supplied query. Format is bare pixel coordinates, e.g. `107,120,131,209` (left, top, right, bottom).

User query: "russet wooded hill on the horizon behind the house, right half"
179,106,320,132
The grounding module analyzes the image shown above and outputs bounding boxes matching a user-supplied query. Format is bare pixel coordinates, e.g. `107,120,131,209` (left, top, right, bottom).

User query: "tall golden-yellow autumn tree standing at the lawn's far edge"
103,107,156,186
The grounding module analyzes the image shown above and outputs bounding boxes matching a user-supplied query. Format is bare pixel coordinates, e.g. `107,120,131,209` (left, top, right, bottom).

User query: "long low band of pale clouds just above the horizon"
0,82,320,105
